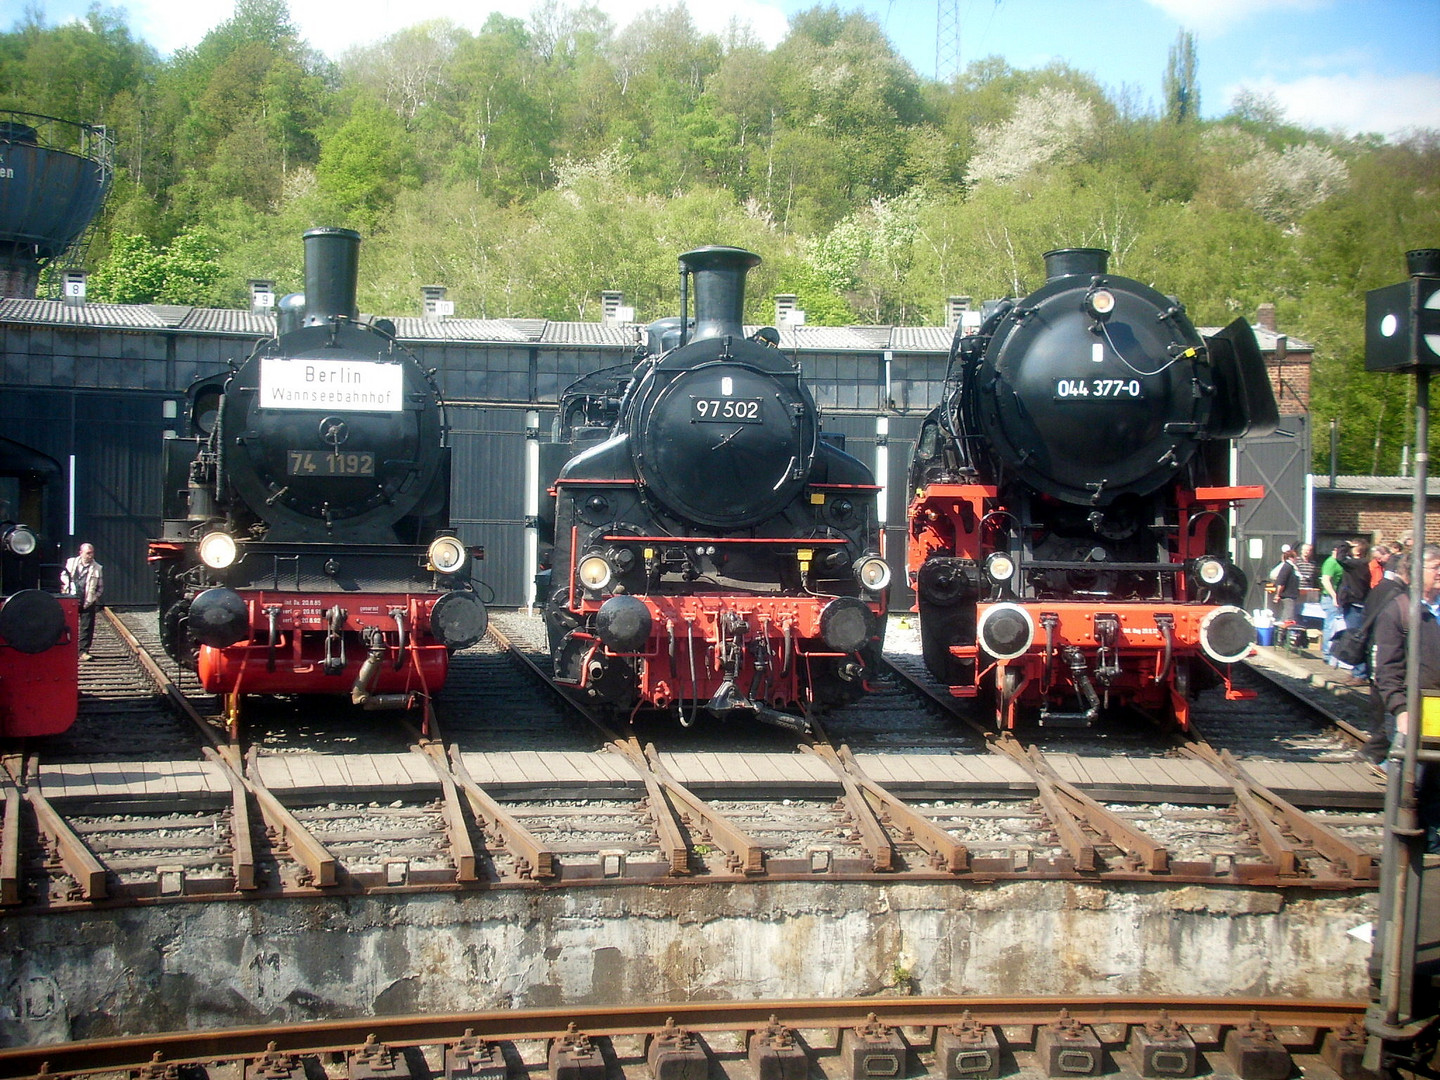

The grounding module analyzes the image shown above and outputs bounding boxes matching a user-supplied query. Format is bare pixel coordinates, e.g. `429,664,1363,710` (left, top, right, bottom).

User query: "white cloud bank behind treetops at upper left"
113,0,789,58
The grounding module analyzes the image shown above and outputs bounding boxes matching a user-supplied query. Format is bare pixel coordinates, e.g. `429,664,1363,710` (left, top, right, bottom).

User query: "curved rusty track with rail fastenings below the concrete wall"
0,996,1365,1080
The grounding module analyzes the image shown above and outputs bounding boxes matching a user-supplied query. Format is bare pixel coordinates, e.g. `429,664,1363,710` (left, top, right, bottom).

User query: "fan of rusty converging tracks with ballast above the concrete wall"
0,616,1381,910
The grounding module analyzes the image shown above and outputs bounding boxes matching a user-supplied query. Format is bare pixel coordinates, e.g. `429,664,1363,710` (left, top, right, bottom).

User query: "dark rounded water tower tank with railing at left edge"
0,111,114,298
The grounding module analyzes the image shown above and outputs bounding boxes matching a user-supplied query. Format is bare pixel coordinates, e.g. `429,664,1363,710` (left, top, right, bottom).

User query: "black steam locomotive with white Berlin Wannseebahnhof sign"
150,229,487,727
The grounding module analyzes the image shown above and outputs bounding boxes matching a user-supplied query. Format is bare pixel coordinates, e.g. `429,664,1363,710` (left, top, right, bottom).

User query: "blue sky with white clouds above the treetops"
16,0,1440,138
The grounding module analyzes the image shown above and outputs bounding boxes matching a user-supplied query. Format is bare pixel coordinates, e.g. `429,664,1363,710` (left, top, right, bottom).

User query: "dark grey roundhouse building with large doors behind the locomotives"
0,282,1309,608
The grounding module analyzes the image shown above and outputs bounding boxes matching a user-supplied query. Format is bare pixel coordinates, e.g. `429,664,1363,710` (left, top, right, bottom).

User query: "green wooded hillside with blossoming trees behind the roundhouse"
0,0,1440,472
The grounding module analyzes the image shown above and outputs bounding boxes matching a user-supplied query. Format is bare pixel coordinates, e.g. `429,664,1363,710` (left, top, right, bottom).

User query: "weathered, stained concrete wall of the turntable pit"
0,883,1374,1045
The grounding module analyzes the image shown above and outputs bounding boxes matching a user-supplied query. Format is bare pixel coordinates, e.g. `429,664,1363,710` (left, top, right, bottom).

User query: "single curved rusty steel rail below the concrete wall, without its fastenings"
0,995,1367,1077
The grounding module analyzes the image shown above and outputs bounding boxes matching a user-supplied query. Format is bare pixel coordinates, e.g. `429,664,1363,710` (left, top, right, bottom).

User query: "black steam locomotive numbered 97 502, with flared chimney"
541,248,890,730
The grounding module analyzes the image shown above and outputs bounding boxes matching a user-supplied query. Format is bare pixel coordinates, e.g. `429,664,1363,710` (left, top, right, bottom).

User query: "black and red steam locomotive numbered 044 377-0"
906,248,1279,729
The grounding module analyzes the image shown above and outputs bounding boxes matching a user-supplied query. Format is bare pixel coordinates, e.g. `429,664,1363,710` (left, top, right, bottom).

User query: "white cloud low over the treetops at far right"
1225,75,1440,135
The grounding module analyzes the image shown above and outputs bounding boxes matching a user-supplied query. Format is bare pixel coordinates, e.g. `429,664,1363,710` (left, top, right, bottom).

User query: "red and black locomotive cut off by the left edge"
0,438,79,737
